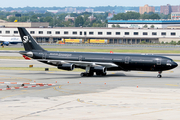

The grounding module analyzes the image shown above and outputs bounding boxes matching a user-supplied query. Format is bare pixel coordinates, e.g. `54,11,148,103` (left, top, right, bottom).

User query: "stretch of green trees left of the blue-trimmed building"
0,12,108,27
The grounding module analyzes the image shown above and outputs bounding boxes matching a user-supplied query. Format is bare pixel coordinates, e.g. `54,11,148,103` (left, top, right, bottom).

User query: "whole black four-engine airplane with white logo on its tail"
18,27,178,78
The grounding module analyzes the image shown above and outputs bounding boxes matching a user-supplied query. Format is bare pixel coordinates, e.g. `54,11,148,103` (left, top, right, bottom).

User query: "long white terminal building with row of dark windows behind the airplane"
0,27,180,44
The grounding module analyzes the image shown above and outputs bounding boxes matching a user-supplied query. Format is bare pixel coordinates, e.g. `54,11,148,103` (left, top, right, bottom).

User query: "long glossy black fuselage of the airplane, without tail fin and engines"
25,51,177,71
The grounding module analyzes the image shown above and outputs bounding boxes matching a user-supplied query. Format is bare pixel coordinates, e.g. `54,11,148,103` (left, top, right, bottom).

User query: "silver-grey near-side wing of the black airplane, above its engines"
38,59,118,68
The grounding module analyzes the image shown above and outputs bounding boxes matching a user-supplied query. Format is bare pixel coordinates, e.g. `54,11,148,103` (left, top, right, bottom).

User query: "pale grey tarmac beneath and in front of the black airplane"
0,55,180,120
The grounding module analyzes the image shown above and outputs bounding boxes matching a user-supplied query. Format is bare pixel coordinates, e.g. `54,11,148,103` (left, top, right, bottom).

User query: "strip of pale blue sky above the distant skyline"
0,0,180,8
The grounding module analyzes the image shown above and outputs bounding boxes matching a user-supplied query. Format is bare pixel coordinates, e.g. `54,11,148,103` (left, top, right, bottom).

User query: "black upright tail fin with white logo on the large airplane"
18,27,45,51
